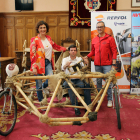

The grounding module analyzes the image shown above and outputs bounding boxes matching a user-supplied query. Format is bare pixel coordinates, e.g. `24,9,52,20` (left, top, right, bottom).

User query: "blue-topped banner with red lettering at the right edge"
131,11,140,94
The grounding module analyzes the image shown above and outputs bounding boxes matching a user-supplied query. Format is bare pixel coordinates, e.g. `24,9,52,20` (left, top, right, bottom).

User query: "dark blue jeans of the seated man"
63,79,91,106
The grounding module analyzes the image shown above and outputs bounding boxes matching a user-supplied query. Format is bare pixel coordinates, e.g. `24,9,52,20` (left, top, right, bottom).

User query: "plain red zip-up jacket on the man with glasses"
87,33,117,66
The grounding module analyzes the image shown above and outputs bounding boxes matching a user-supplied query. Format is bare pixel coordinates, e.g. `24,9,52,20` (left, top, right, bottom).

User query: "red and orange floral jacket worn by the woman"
30,35,66,74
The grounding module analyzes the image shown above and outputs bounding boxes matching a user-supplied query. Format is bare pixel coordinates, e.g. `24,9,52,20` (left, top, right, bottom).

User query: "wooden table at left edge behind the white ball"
0,57,15,89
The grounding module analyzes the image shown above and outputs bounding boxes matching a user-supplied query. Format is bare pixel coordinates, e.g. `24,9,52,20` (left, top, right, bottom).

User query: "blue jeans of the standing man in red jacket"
95,65,112,100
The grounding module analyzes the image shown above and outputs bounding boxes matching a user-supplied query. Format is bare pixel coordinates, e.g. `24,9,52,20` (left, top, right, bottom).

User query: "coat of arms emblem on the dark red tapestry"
84,0,101,12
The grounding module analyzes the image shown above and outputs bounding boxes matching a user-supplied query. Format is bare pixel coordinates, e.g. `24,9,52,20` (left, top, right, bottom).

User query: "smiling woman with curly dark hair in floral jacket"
30,21,66,101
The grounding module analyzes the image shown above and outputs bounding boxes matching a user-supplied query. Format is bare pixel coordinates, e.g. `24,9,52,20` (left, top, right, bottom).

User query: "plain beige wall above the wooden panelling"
0,0,140,12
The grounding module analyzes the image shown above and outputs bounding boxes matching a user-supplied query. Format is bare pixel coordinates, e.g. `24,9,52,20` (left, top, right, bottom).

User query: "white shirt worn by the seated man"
61,56,84,75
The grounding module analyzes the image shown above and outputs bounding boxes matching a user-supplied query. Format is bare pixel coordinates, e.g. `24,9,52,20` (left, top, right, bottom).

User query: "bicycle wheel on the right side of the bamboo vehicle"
114,88,121,129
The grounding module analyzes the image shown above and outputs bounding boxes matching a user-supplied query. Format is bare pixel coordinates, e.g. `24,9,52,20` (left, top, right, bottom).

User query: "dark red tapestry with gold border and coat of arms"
69,0,117,28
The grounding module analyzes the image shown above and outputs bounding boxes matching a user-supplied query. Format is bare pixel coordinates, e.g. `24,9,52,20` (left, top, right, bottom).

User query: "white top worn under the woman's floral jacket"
41,38,52,61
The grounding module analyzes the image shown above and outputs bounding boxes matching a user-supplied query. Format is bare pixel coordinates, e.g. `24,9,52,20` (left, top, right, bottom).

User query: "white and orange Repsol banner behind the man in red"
91,11,131,92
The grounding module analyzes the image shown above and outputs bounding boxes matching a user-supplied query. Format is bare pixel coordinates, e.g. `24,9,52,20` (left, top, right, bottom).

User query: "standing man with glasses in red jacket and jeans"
86,21,117,107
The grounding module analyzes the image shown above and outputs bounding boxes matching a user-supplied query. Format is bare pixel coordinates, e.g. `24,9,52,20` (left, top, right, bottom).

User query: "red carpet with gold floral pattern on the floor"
0,94,140,140
